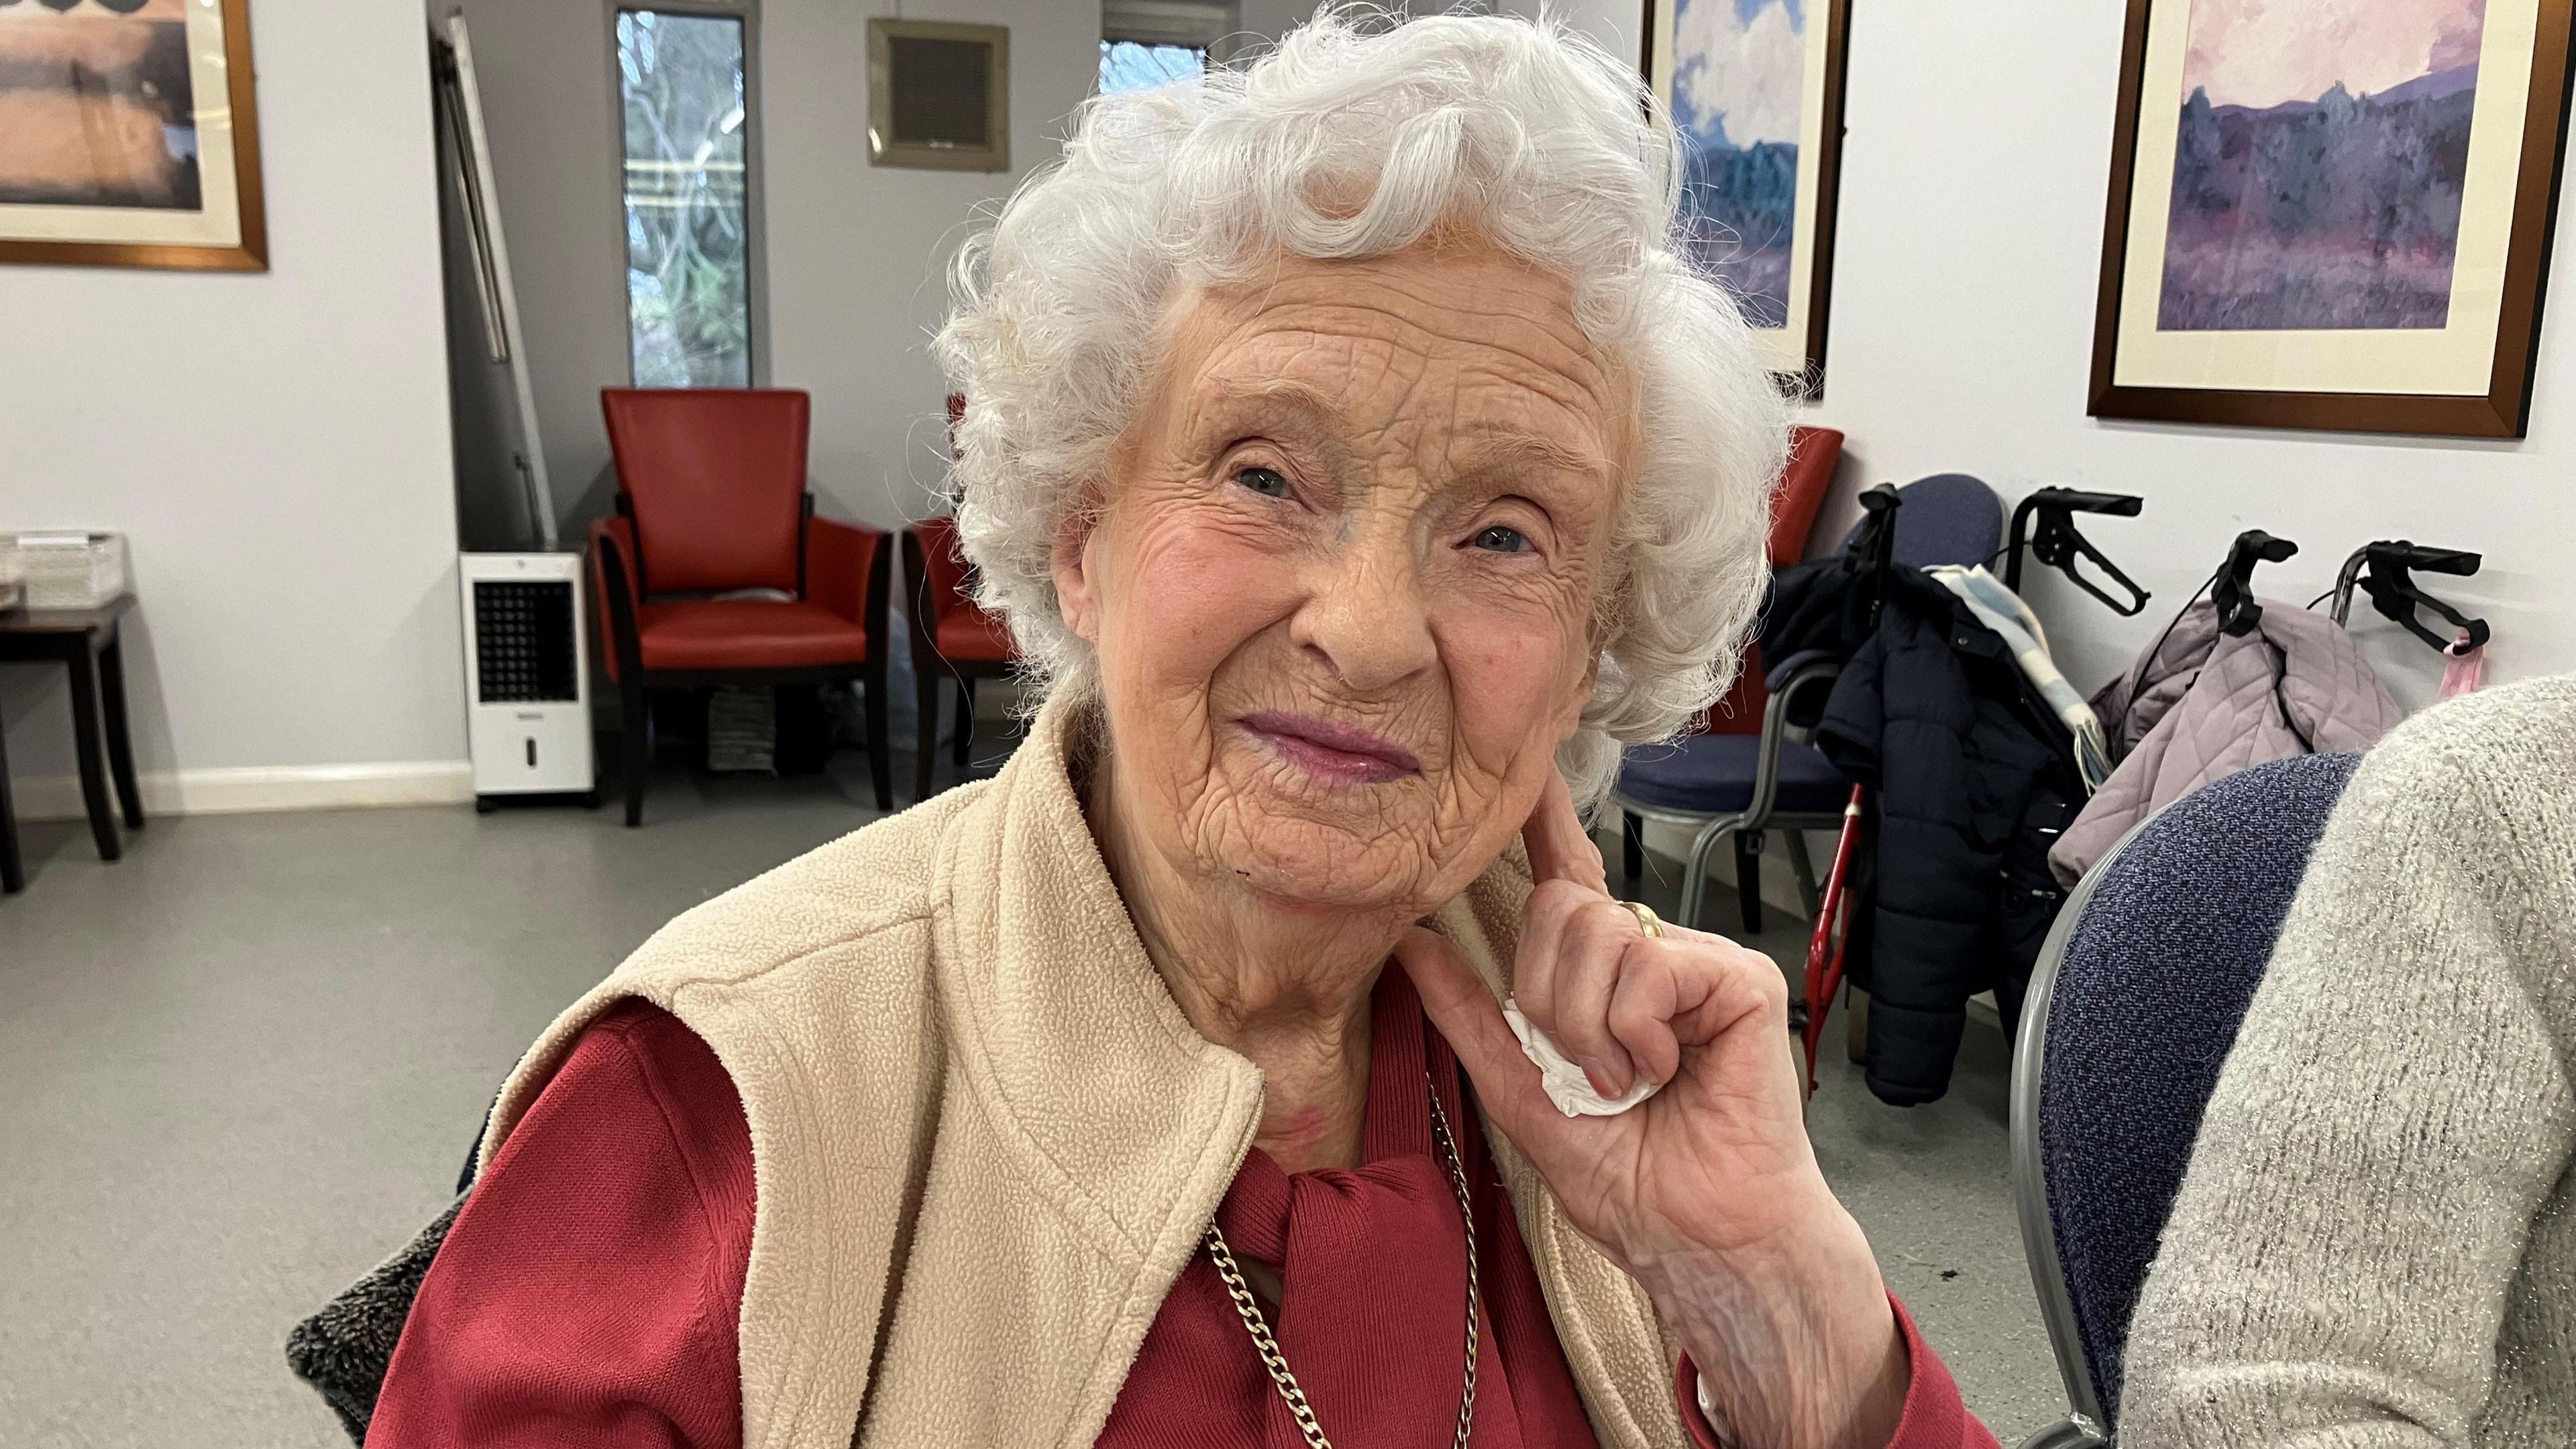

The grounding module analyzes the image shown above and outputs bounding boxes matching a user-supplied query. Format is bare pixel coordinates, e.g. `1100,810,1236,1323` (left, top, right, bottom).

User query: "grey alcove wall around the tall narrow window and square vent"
445,0,1100,541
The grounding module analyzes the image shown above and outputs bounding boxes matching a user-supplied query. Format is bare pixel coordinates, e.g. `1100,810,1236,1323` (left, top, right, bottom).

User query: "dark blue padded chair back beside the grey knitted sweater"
2012,755,2359,1449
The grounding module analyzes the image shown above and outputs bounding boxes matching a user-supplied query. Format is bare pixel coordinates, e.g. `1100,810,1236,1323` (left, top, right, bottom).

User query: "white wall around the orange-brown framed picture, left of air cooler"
0,0,464,789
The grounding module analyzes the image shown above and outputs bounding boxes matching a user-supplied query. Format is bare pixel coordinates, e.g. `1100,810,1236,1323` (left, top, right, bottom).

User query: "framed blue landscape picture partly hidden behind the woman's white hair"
1644,0,1852,394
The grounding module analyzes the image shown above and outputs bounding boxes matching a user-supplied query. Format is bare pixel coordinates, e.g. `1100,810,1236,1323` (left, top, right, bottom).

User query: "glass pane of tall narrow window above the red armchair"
619,10,752,387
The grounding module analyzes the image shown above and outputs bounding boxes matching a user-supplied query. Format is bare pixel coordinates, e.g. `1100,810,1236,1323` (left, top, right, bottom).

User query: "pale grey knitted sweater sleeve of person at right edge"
2120,678,2576,1449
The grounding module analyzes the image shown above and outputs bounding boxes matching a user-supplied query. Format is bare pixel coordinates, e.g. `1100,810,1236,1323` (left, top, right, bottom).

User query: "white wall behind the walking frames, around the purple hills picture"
1556,0,2576,706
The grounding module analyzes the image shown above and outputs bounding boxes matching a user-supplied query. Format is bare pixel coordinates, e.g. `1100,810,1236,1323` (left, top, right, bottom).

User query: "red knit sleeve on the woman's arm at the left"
366,1003,752,1449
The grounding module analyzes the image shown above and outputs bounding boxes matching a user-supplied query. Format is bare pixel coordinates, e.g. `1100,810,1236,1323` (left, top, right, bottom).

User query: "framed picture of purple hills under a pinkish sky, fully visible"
2089,0,2571,438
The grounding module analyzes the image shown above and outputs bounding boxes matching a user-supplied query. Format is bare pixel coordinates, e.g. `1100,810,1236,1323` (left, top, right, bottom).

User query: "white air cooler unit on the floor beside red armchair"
456,554,598,807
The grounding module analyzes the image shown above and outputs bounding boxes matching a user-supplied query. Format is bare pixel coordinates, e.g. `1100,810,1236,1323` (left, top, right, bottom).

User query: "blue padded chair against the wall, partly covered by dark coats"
1618,472,2004,933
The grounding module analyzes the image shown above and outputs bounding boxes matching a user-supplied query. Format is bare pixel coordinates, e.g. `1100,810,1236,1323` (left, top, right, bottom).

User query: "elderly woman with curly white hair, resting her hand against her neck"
371,15,1991,1449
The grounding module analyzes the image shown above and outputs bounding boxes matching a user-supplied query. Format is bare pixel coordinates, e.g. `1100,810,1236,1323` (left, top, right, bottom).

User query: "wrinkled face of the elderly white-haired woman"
1056,242,1633,910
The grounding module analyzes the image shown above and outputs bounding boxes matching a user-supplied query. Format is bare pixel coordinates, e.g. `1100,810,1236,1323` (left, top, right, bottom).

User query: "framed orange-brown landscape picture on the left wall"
0,0,268,271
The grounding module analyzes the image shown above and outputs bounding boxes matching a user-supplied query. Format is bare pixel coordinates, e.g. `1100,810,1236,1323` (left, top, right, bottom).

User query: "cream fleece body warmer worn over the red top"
484,706,1687,1449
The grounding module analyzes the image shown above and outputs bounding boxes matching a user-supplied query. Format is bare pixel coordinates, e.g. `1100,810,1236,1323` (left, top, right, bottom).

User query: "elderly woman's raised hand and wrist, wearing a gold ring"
1396,779,1909,1449
